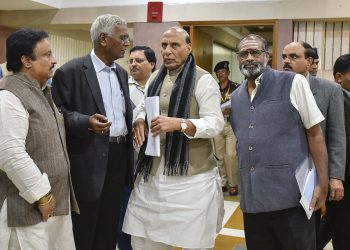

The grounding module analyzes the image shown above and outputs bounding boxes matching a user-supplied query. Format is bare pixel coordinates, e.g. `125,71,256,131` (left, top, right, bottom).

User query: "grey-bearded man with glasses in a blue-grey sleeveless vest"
231,34,328,250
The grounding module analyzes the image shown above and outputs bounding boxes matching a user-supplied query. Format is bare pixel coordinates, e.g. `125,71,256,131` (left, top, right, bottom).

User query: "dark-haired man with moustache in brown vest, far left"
0,29,76,250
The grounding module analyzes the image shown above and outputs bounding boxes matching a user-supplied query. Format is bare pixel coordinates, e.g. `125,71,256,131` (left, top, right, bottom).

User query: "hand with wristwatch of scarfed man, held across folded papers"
151,116,182,136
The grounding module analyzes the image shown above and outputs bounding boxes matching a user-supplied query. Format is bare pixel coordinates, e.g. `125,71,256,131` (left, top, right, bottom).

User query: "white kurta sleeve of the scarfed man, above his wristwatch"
188,74,225,138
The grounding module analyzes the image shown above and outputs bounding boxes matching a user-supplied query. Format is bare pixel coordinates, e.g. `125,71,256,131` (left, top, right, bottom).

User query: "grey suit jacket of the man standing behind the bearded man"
309,75,346,180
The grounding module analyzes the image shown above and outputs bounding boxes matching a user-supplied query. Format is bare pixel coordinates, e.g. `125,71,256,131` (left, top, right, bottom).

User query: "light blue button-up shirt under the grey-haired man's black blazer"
91,50,128,136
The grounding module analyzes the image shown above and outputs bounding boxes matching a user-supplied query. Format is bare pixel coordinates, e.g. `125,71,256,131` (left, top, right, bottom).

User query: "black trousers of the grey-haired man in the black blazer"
72,143,128,250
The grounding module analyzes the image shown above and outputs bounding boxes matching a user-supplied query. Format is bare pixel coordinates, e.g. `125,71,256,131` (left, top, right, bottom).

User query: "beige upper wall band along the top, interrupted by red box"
0,0,350,26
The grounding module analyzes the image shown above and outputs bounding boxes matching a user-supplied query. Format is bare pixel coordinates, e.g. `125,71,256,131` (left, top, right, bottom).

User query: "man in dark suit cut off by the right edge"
327,54,350,250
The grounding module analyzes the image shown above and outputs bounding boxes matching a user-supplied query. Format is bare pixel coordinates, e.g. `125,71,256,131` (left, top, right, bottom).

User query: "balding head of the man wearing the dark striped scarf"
161,27,192,70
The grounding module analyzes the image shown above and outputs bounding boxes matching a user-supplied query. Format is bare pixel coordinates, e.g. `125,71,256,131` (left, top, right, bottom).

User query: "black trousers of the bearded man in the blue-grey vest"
243,207,316,250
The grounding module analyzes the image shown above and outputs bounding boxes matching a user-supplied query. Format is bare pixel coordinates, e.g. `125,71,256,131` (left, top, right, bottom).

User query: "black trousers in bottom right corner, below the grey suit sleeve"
319,181,350,250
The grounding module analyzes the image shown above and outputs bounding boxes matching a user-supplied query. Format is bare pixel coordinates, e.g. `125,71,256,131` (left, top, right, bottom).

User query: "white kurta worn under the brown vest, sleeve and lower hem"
0,90,75,250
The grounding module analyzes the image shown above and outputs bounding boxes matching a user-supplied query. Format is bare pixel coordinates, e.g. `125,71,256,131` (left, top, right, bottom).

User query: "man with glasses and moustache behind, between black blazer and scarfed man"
129,46,157,121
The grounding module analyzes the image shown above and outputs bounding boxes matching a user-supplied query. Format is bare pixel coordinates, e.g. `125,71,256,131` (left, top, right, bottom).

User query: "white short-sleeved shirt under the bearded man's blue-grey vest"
250,74,324,129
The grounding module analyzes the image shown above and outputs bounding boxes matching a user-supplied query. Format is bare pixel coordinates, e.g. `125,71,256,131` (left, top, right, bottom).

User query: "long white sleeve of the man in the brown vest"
0,90,51,203
